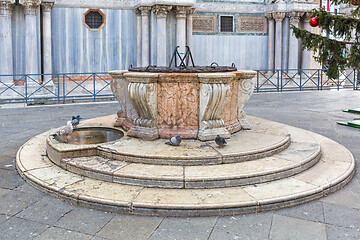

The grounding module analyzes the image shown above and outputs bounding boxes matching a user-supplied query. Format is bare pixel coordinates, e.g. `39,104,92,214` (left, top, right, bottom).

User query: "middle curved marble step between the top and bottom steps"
58,138,321,188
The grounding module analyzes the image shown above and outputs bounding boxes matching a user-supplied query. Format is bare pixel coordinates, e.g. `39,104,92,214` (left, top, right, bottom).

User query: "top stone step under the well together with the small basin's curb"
46,118,291,166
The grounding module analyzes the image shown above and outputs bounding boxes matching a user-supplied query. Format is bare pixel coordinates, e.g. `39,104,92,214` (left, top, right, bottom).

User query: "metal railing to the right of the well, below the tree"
255,69,359,92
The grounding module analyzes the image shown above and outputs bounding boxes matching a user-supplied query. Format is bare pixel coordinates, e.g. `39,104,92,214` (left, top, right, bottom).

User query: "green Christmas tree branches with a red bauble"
291,4,360,79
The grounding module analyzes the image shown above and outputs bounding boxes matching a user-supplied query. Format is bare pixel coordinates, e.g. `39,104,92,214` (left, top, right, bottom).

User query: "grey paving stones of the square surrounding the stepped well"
0,90,360,240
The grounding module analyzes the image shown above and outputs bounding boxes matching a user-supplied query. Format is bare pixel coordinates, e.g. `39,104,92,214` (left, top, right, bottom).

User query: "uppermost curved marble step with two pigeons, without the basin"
97,129,291,166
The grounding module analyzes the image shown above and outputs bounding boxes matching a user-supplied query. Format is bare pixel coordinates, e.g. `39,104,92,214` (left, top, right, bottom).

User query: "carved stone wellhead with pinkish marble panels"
109,71,256,141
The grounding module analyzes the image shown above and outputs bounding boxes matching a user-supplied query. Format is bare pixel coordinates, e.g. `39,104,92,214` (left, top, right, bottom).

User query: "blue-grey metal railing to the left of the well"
0,72,114,104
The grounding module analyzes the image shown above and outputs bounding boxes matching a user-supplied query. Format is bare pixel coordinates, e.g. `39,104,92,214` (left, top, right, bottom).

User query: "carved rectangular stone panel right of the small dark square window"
237,16,267,33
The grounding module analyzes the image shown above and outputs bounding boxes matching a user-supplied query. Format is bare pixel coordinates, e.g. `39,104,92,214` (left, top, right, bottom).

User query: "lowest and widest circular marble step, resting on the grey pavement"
16,128,355,216
